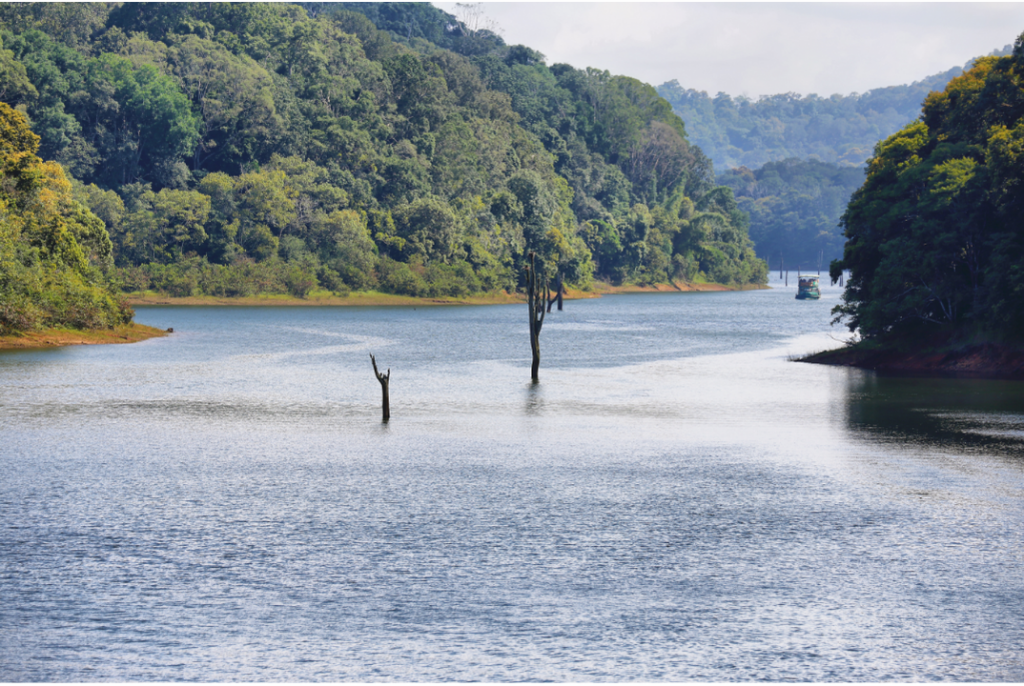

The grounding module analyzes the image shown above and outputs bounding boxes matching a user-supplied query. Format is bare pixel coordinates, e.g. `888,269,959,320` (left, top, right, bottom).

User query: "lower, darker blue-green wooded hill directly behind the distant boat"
718,160,864,270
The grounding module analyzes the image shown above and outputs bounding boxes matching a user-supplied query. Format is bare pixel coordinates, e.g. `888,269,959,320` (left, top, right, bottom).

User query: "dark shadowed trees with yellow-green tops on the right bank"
831,35,1024,344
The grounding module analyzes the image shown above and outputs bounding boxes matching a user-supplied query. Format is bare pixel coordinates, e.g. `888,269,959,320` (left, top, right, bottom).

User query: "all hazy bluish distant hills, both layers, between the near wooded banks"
657,45,1013,269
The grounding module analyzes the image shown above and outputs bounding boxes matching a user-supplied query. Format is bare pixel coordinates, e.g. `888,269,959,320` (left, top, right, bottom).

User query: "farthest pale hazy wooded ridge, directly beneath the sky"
657,45,1013,172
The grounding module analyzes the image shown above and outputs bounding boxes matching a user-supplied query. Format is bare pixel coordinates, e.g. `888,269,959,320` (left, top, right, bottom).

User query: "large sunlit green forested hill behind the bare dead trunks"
0,3,766,329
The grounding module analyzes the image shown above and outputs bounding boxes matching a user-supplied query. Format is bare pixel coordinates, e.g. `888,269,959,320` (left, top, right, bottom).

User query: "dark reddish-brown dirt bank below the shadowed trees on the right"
799,343,1024,380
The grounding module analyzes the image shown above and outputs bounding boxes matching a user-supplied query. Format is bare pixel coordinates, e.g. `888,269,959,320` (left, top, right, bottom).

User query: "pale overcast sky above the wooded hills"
434,2,1024,98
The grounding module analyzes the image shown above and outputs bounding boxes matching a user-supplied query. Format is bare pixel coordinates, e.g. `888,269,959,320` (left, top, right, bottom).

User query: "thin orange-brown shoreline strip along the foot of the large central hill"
125,282,768,307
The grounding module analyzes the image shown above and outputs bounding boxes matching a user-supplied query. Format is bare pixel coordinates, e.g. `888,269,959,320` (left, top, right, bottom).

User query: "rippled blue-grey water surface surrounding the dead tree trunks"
0,280,1024,682
